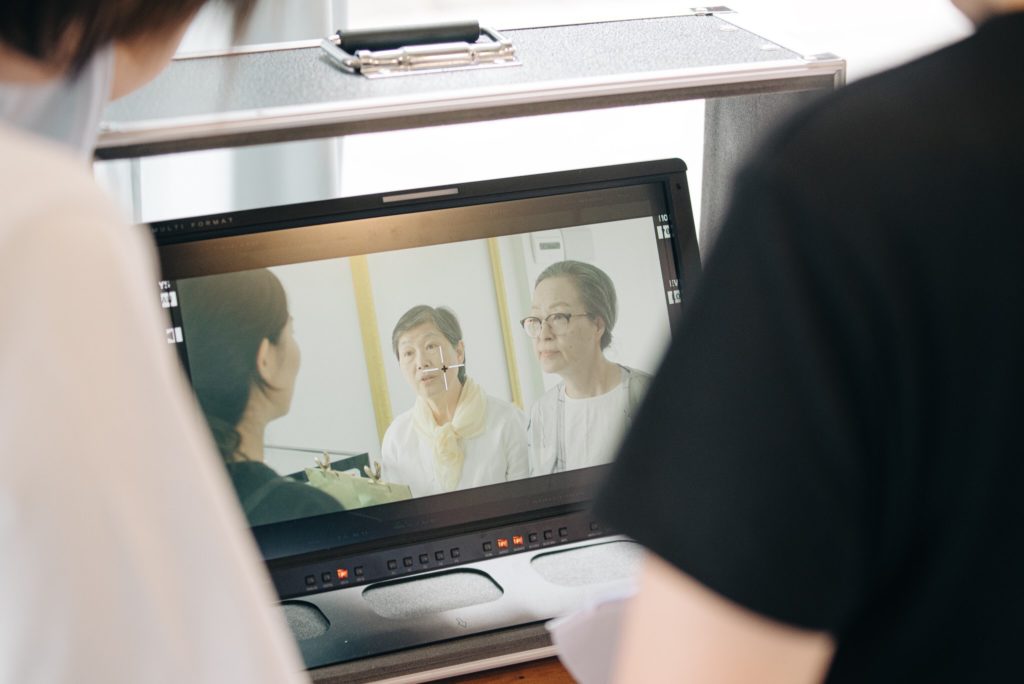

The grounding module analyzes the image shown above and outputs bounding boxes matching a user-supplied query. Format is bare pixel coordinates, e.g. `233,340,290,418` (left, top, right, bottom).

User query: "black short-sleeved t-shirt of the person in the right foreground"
598,13,1024,682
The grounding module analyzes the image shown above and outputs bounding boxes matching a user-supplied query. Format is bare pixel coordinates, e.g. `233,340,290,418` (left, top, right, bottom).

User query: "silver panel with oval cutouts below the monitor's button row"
283,538,641,681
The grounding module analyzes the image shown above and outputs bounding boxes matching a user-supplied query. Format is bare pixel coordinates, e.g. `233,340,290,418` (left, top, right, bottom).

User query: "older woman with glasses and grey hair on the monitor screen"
521,261,650,475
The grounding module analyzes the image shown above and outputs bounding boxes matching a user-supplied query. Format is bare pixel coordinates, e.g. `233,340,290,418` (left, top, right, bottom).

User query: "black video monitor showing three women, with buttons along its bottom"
152,160,699,598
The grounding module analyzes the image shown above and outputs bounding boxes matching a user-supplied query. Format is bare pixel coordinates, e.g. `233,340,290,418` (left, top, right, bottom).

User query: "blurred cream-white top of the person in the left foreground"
0,188,304,684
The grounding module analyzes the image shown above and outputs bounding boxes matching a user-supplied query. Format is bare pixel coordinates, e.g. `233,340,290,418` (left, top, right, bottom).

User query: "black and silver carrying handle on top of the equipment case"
321,23,522,79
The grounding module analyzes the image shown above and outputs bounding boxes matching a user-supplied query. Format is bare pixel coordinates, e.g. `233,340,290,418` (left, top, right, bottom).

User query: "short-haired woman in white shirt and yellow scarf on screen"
381,304,528,497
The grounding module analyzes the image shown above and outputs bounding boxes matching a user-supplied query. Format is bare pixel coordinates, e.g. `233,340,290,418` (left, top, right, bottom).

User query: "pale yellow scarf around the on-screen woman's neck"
413,378,487,491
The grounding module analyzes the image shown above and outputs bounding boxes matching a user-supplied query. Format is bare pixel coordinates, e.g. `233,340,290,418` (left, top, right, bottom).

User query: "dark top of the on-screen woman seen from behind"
226,461,344,526
